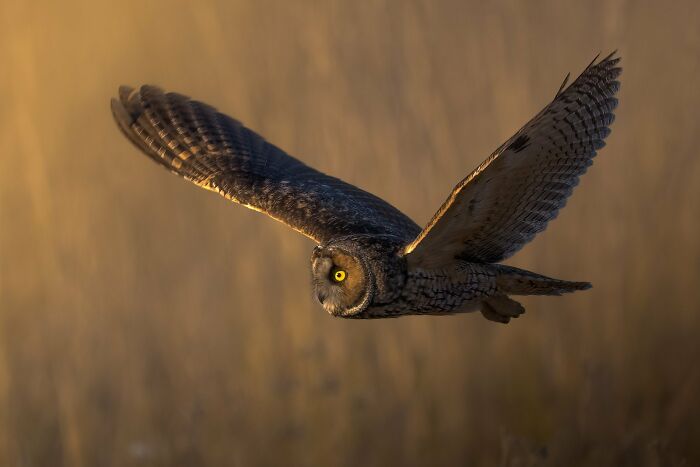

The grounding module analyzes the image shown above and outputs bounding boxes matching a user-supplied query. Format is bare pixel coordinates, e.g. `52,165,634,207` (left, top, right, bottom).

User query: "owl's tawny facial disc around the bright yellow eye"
311,247,372,316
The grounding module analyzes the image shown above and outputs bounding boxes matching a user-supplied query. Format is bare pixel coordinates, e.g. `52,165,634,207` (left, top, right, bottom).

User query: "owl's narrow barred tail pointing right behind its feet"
496,264,591,295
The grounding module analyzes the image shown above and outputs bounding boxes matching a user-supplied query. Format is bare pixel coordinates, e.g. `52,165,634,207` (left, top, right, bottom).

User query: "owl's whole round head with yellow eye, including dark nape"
311,235,406,318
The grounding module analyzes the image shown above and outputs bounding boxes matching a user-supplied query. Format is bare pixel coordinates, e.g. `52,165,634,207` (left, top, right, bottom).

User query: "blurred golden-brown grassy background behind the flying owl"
0,0,700,466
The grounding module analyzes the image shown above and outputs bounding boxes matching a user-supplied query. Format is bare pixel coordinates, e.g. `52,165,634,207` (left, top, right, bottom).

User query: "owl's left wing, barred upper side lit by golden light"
112,86,420,243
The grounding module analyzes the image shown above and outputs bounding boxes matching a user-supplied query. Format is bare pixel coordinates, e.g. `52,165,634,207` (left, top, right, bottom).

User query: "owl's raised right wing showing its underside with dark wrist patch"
403,52,622,268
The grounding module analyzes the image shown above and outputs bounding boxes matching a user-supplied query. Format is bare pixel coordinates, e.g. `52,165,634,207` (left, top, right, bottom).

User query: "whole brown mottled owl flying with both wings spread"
112,52,622,323
